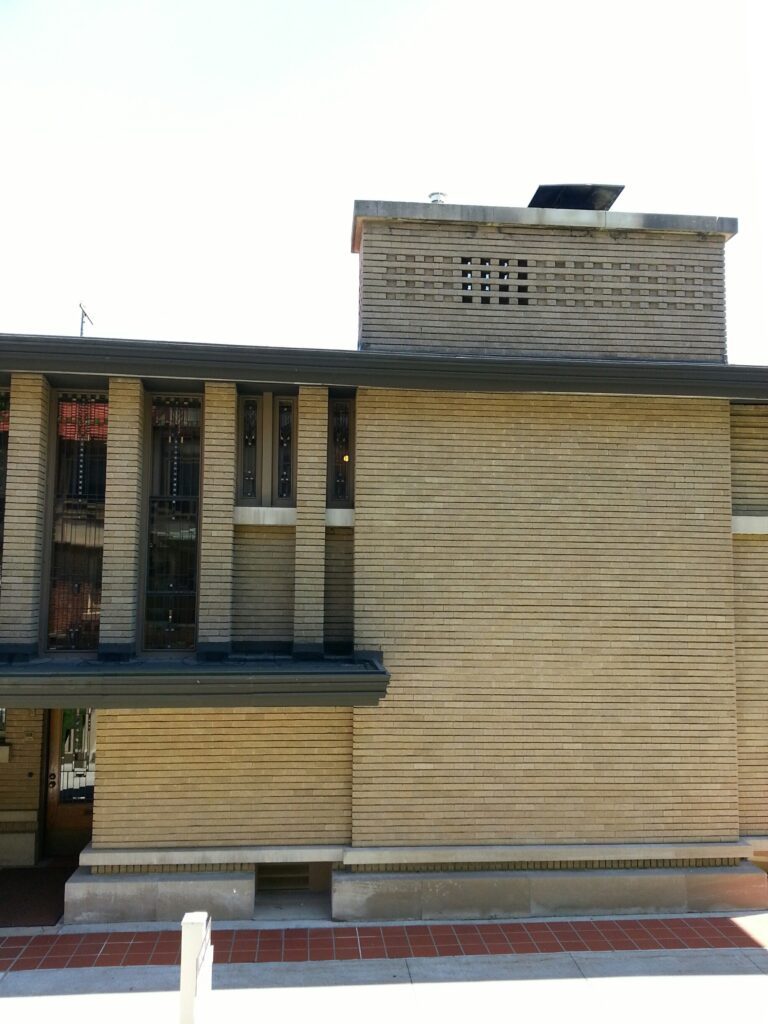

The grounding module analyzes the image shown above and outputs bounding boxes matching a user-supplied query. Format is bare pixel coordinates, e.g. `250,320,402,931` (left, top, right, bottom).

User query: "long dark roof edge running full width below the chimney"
0,335,768,401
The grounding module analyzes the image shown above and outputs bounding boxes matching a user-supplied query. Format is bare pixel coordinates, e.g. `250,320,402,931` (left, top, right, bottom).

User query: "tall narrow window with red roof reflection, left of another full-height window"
48,394,108,650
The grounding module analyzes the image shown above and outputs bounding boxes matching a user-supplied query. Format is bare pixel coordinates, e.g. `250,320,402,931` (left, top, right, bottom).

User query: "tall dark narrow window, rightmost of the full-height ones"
144,396,201,650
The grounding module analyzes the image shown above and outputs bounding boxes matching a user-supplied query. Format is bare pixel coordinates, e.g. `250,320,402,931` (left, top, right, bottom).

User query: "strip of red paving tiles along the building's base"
0,916,768,972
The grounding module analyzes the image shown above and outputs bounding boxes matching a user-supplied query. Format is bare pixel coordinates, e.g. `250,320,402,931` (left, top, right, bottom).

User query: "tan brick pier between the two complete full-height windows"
98,377,144,646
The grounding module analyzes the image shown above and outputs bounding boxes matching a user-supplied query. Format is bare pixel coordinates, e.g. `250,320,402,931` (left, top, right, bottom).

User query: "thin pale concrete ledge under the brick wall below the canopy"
80,844,344,878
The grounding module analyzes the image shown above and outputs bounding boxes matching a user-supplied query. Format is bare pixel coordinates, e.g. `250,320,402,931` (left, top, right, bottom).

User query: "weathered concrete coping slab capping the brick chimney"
352,199,738,253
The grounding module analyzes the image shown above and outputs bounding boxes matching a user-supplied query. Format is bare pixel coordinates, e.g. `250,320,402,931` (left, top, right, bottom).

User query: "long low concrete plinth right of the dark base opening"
332,864,768,922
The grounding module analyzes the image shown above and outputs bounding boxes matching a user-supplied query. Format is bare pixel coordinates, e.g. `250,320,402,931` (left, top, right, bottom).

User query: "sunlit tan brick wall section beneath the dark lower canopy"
93,708,351,847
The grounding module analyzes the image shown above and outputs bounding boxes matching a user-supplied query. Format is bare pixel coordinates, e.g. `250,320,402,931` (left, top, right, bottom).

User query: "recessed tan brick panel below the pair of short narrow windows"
232,526,295,645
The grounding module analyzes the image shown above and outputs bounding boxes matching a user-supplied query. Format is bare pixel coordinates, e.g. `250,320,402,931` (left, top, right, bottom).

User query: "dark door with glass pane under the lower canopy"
44,708,96,857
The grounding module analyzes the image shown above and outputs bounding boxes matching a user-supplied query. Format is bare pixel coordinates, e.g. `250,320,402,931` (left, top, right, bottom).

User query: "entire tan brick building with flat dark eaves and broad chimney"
0,186,768,921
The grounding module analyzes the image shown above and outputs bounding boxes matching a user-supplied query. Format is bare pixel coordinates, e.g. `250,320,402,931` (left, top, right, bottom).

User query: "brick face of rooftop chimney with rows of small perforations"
359,221,725,362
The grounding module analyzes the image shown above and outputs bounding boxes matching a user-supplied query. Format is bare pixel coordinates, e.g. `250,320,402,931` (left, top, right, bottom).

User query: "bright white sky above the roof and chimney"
0,0,768,364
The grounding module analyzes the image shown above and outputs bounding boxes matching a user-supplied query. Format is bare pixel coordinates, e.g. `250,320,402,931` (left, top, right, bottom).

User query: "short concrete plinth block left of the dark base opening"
63,867,256,925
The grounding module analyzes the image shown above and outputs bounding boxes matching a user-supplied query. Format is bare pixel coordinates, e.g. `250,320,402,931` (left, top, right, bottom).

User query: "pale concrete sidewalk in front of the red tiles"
0,949,768,1024
